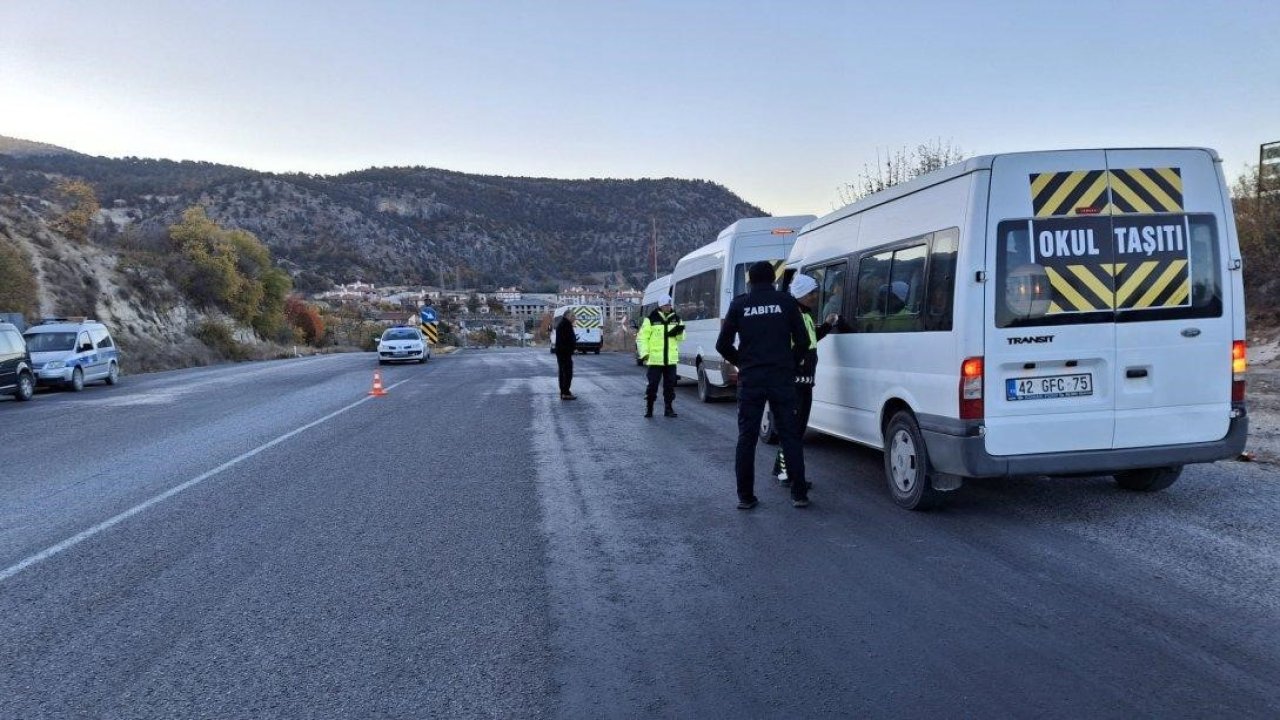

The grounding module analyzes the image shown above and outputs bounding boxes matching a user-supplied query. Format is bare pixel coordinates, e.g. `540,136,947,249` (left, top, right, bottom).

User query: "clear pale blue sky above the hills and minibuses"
0,0,1280,215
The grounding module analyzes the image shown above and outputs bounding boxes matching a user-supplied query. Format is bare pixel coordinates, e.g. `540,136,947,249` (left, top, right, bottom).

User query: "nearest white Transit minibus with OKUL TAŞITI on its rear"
785,149,1248,509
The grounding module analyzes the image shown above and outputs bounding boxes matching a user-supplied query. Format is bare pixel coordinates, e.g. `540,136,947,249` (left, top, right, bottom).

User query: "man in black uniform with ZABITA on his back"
716,263,809,510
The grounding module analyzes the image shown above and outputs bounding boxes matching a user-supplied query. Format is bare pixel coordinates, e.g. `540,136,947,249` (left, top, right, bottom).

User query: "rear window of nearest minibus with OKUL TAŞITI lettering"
996,214,1222,328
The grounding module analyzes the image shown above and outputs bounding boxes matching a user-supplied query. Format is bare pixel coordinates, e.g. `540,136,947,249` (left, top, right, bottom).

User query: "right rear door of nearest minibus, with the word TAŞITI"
1107,150,1235,447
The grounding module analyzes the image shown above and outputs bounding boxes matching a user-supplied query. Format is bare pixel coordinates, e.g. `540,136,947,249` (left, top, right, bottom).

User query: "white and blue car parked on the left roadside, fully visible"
23,318,120,392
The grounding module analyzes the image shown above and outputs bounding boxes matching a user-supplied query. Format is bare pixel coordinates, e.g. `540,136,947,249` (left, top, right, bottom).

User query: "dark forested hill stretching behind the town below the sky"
0,146,765,290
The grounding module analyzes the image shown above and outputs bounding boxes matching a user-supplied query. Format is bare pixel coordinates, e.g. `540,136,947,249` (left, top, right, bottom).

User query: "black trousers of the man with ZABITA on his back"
733,377,809,501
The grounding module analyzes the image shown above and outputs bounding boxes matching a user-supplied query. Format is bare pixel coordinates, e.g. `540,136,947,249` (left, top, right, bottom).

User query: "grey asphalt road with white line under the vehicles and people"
0,351,1280,719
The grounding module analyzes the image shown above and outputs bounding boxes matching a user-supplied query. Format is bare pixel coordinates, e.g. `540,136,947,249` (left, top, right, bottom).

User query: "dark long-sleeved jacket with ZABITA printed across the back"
716,283,809,384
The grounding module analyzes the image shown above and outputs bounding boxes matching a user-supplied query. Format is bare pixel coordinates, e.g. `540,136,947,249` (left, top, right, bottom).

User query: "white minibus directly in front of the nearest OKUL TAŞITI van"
671,215,814,402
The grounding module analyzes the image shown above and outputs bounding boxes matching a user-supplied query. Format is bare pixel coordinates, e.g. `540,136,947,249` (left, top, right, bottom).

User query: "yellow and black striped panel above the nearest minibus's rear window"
1029,168,1183,218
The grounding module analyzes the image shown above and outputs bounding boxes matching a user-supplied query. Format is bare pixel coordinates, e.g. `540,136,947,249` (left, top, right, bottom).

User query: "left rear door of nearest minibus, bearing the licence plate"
983,150,1116,456
